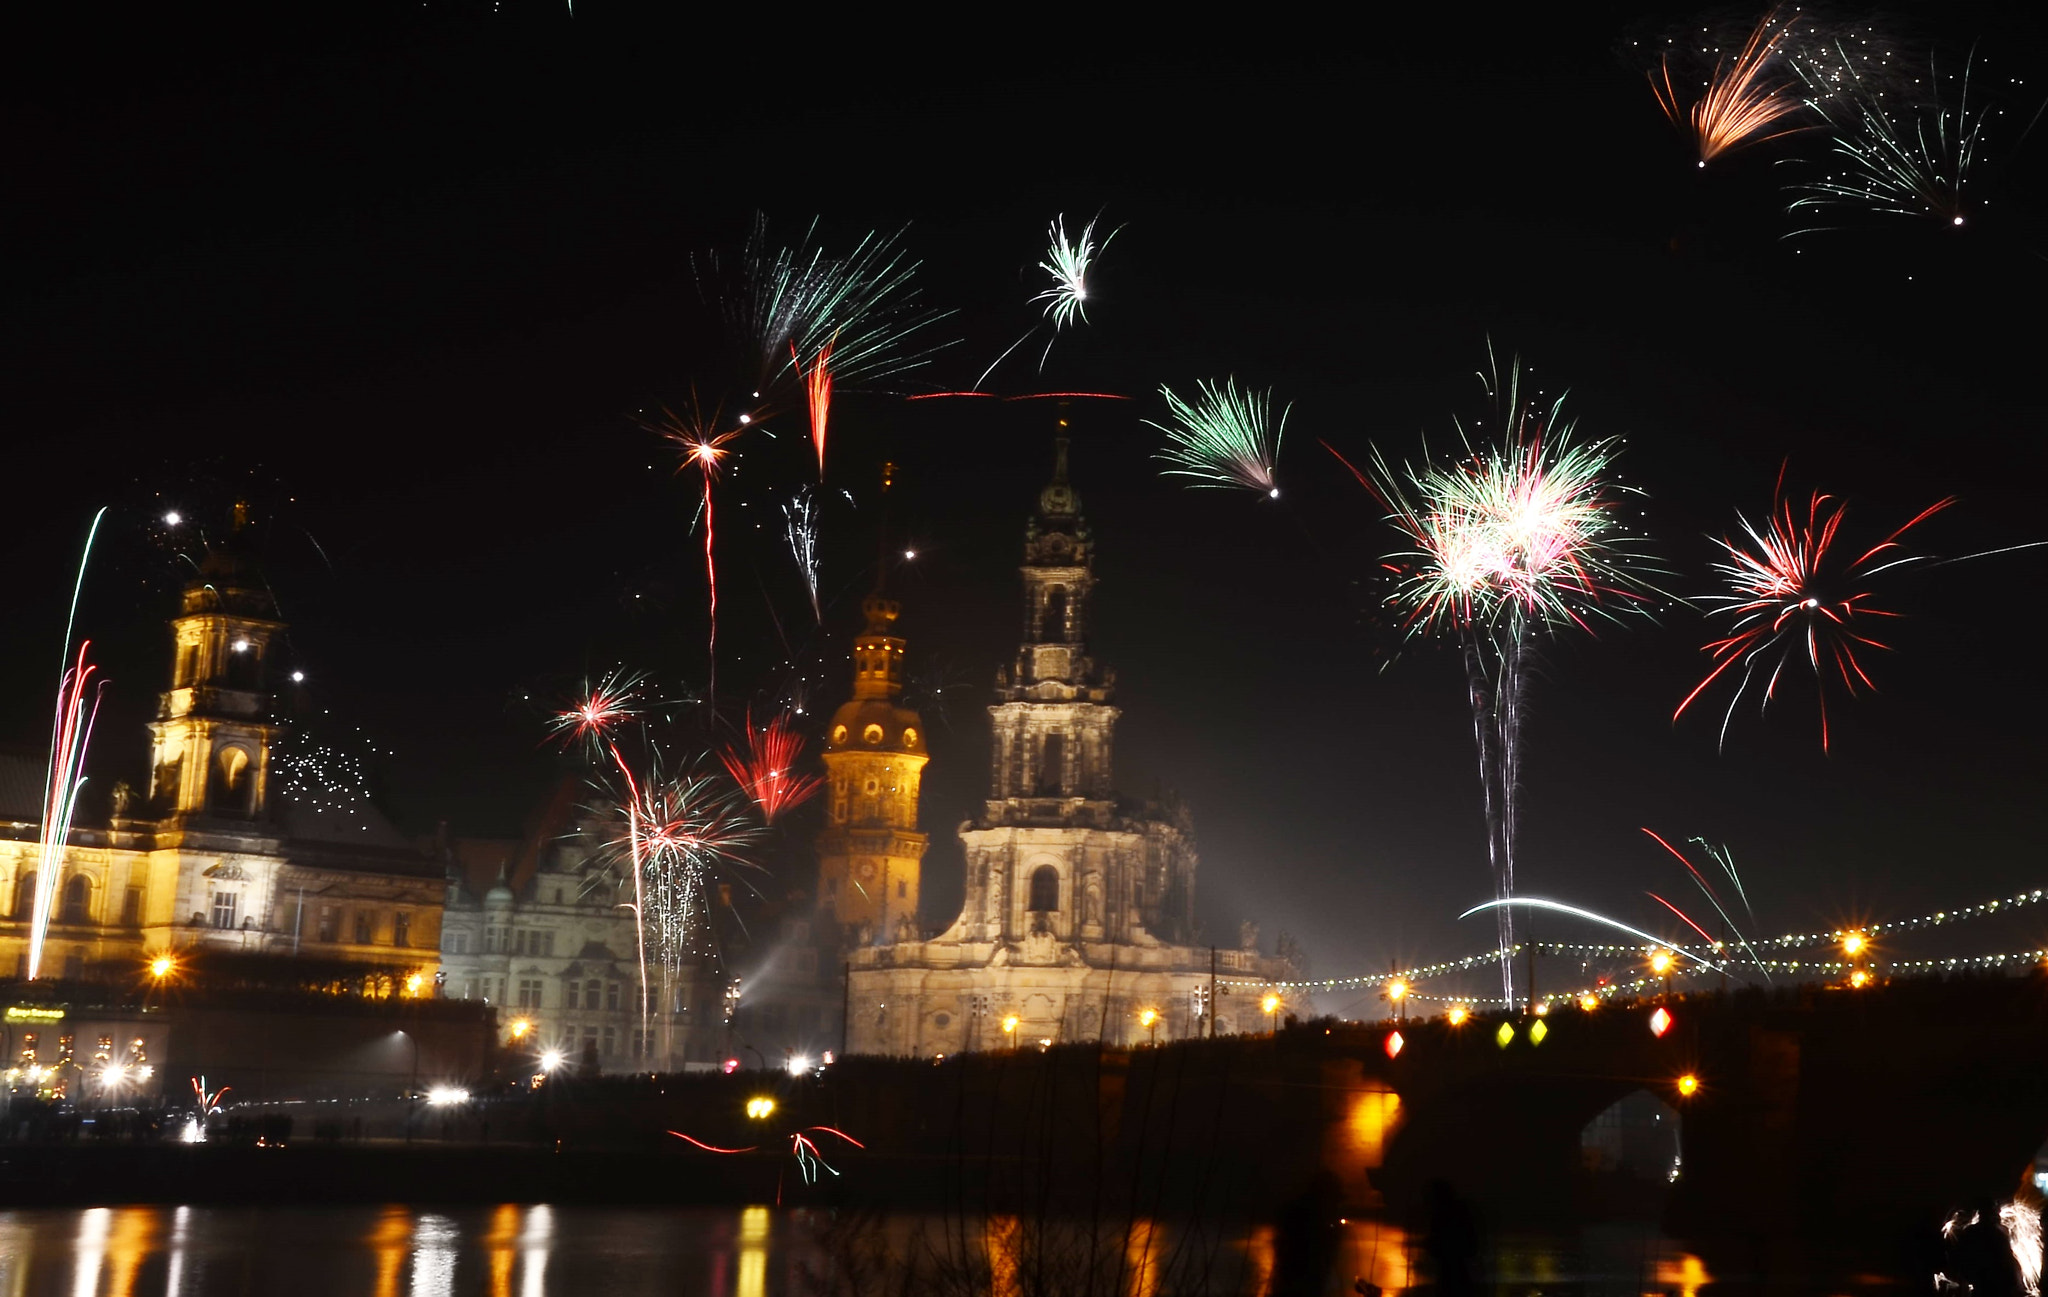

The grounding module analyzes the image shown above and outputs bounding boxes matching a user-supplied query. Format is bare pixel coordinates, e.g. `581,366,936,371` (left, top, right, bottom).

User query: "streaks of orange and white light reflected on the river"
0,1203,1712,1297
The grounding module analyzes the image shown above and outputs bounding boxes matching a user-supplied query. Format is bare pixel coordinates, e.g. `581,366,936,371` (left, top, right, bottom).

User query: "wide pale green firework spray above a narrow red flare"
700,215,952,387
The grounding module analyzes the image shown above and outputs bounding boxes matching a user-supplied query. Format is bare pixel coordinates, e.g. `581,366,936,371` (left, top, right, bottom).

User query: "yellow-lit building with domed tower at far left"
0,520,444,994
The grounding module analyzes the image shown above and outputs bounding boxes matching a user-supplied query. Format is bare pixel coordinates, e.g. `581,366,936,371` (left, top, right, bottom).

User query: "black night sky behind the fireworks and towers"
0,4,2048,1008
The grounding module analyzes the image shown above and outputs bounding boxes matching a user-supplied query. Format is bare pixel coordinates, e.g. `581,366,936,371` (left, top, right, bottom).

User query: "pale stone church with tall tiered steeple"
848,438,1284,1055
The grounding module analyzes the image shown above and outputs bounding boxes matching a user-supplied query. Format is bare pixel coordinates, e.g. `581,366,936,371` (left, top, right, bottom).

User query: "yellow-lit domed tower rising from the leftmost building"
150,504,285,820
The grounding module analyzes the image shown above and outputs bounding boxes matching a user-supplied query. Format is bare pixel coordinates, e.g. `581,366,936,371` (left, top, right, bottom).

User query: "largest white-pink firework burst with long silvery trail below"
1359,352,1659,1002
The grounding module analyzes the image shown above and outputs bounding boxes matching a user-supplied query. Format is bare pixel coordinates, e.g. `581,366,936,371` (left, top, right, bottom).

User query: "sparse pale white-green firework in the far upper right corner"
1786,53,1987,238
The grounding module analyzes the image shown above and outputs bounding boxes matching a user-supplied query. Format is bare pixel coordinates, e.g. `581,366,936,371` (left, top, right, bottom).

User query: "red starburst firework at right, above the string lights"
1671,471,1956,752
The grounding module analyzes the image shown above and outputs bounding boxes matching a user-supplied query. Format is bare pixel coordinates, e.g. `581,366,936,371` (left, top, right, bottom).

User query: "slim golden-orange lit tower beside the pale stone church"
817,465,930,940
